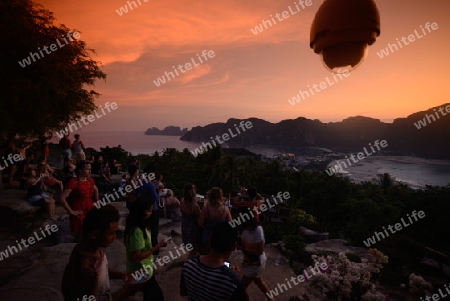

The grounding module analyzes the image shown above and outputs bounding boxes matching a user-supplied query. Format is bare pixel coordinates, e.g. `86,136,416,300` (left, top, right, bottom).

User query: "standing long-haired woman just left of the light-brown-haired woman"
180,183,201,256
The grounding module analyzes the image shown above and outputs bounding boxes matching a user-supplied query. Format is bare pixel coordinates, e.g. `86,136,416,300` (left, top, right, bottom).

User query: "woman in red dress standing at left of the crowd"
61,161,99,236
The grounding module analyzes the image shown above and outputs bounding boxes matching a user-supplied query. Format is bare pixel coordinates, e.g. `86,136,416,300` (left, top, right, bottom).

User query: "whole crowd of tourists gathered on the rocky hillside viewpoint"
2,135,269,301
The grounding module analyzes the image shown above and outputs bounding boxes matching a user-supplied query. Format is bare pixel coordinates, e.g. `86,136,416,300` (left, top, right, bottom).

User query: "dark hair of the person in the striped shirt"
211,221,238,253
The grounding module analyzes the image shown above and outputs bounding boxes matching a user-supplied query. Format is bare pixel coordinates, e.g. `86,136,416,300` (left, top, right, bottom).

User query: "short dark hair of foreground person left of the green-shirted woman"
83,205,120,237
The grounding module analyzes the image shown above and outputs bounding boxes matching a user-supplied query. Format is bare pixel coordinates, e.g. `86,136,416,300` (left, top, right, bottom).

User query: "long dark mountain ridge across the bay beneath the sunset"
180,104,450,159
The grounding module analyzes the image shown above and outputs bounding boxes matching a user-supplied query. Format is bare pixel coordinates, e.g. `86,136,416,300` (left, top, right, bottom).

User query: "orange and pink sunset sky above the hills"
37,0,450,130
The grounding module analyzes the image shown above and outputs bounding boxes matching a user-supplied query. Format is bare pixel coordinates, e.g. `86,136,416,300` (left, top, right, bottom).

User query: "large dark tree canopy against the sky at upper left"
0,0,106,138
